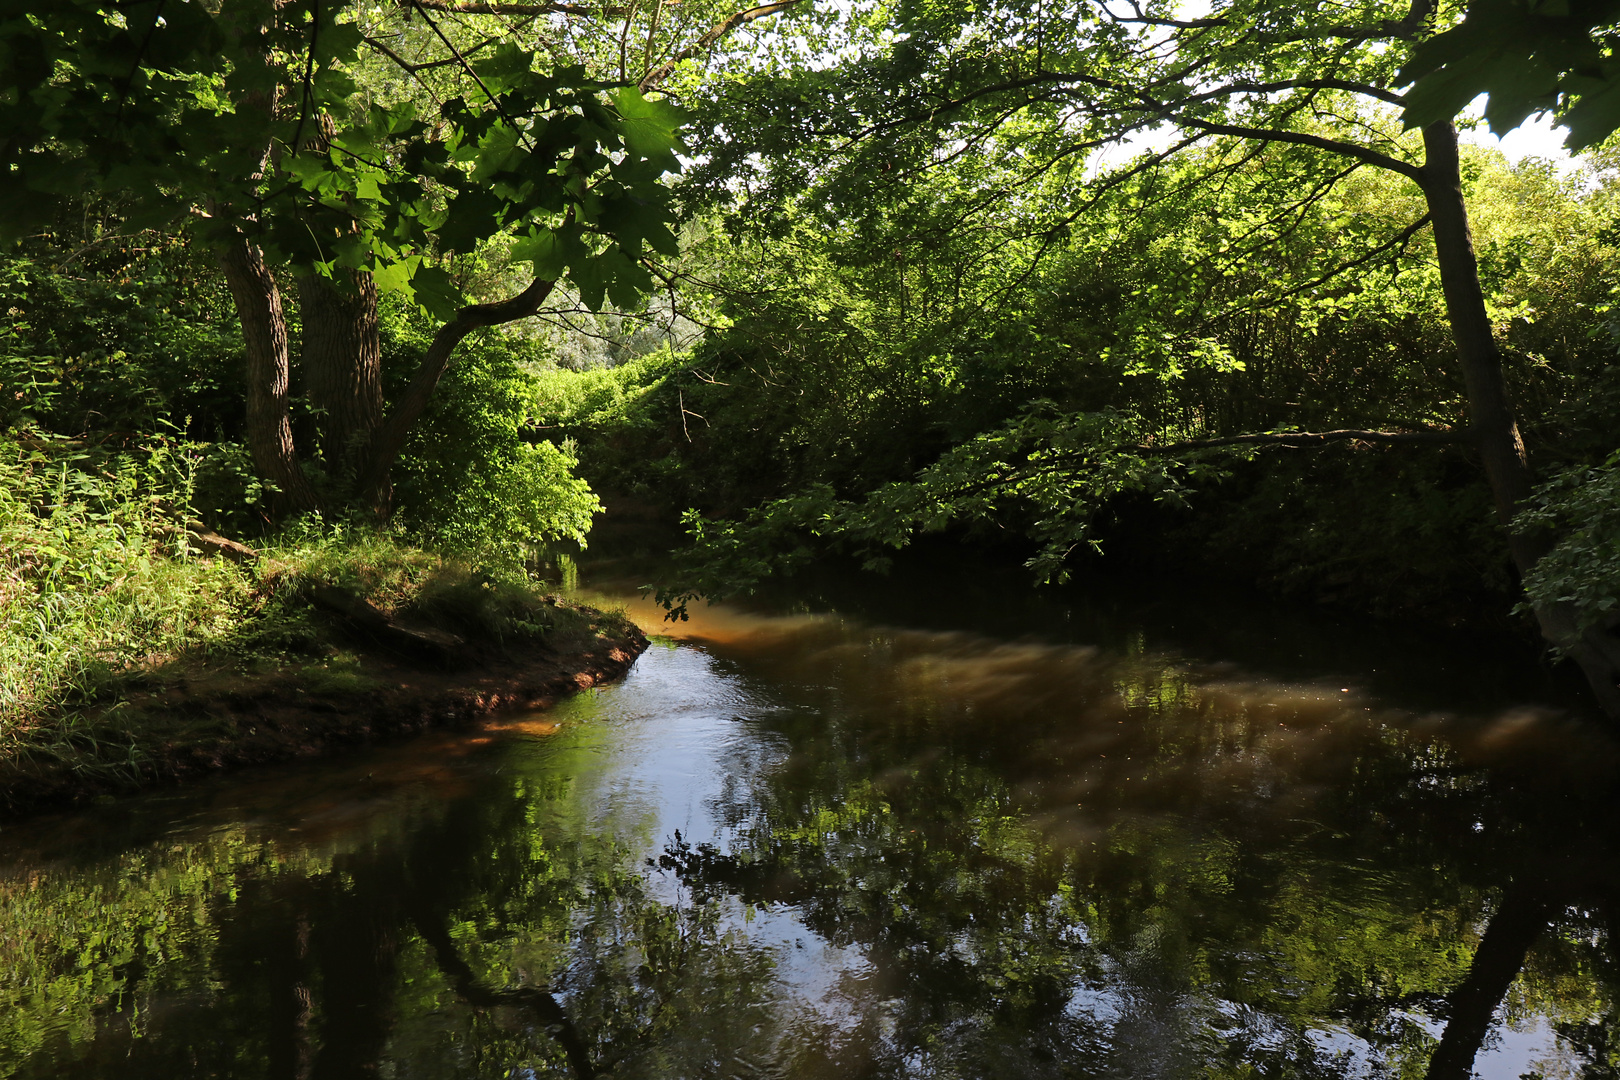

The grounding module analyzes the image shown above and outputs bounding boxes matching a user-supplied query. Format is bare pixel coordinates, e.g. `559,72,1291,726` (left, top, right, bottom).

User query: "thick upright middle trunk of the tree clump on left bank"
298,270,382,483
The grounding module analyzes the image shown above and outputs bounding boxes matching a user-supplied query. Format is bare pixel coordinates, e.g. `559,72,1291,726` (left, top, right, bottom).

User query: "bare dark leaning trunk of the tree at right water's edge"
1422,121,1620,717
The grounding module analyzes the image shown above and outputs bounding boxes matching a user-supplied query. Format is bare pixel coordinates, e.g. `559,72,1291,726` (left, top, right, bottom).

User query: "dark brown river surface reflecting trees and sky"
0,563,1620,1080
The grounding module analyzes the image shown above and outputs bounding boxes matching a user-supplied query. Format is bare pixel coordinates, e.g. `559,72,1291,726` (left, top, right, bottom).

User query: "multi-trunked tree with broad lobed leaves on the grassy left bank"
0,0,792,513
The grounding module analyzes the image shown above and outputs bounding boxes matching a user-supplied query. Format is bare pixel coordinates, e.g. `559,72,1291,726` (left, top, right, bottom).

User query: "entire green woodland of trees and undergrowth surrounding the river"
0,0,1620,751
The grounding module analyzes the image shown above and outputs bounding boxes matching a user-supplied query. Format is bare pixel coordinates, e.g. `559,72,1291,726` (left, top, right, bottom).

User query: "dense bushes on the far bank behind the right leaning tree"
543,137,1620,622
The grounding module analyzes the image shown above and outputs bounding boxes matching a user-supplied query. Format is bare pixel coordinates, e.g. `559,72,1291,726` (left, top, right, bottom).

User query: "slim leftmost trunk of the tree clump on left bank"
220,238,318,512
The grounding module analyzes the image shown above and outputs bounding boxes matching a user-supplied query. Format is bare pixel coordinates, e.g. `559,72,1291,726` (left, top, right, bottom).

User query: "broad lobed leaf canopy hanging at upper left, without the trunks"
0,0,682,319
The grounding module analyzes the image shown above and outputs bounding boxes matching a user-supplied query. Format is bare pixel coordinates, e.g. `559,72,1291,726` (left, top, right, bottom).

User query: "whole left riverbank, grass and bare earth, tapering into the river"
0,507,646,818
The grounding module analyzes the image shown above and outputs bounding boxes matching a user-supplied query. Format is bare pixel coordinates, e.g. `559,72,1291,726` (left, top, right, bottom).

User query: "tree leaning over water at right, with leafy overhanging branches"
667,0,1620,716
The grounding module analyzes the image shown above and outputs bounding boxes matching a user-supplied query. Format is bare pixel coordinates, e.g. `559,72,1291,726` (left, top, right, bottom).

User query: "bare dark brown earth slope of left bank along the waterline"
0,623,648,819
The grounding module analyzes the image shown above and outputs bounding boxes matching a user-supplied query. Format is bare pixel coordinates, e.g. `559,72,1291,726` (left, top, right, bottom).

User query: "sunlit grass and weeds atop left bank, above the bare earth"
0,452,622,771
